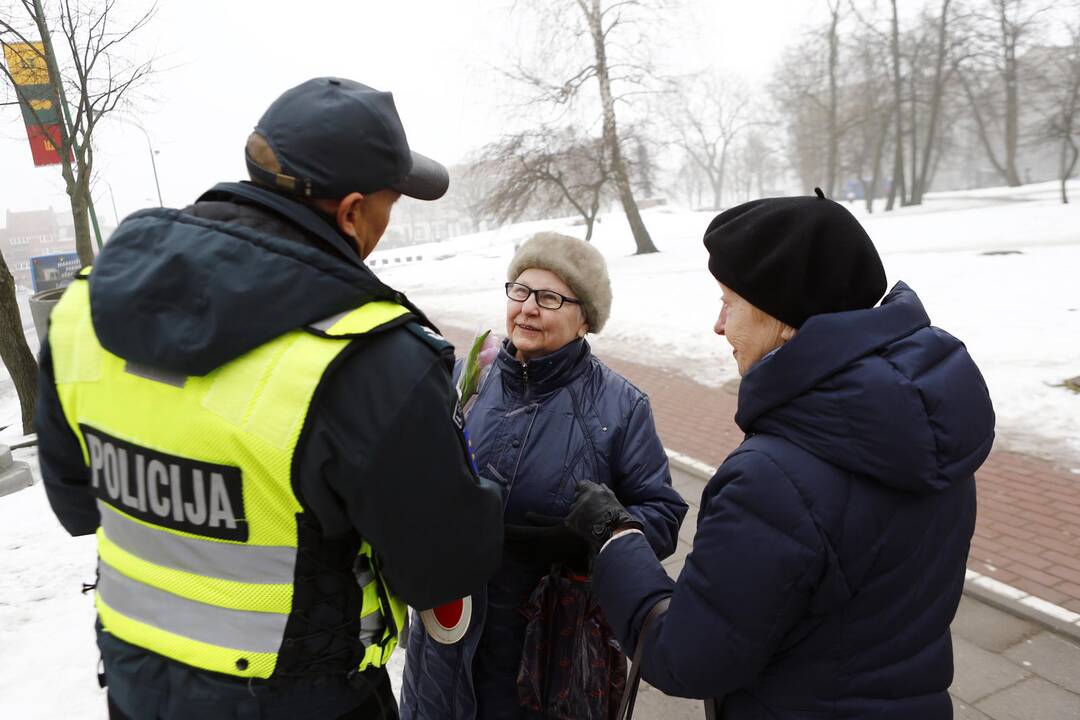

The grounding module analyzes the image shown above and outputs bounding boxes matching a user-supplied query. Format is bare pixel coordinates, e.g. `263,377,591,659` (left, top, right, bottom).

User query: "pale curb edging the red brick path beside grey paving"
664,448,1080,642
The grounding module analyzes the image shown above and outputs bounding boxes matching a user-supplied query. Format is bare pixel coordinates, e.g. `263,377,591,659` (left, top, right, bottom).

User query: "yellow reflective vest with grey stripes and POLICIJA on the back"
49,272,408,678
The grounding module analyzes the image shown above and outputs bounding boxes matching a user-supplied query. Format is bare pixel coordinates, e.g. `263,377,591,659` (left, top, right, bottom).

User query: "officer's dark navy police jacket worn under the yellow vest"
35,184,502,720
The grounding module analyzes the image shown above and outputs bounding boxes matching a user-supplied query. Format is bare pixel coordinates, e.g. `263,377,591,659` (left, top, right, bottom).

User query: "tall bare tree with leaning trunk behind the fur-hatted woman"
510,0,662,255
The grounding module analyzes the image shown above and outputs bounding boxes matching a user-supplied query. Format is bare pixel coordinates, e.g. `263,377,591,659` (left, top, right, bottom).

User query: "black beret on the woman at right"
705,190,886,327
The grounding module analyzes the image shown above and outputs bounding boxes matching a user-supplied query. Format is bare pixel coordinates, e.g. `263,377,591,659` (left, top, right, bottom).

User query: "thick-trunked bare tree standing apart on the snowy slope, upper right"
960,0,1049,187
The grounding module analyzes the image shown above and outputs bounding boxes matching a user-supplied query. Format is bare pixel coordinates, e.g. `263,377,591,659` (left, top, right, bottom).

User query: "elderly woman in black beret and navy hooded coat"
568,191,995,720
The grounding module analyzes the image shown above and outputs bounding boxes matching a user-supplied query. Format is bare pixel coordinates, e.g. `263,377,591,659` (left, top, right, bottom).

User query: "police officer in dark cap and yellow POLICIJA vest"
36,78,502,720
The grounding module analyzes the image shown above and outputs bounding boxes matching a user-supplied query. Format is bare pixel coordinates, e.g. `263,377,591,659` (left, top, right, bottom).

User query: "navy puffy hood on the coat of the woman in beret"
735,283,995,494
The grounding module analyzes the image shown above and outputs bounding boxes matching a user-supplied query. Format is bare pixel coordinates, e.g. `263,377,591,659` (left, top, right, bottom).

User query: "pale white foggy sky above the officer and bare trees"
0,0,824,225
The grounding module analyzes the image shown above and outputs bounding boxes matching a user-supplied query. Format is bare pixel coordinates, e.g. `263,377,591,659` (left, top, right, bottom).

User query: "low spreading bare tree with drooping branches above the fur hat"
477,128,613,241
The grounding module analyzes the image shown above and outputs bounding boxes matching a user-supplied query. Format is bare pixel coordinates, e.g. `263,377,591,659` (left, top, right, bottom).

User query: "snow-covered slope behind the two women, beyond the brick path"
375,182,1080,466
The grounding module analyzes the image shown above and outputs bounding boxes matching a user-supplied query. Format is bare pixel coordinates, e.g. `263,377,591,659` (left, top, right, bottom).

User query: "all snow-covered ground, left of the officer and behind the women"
0,182,1080,720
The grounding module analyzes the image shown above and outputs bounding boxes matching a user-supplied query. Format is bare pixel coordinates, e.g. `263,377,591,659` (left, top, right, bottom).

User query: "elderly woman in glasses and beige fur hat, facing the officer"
402,232,687,720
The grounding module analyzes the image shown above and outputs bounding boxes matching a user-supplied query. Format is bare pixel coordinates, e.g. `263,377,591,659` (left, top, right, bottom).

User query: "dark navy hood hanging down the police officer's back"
90,185,406,376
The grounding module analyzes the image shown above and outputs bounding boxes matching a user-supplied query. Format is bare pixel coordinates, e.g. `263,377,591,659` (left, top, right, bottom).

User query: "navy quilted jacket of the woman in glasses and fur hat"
401,340,687,720
